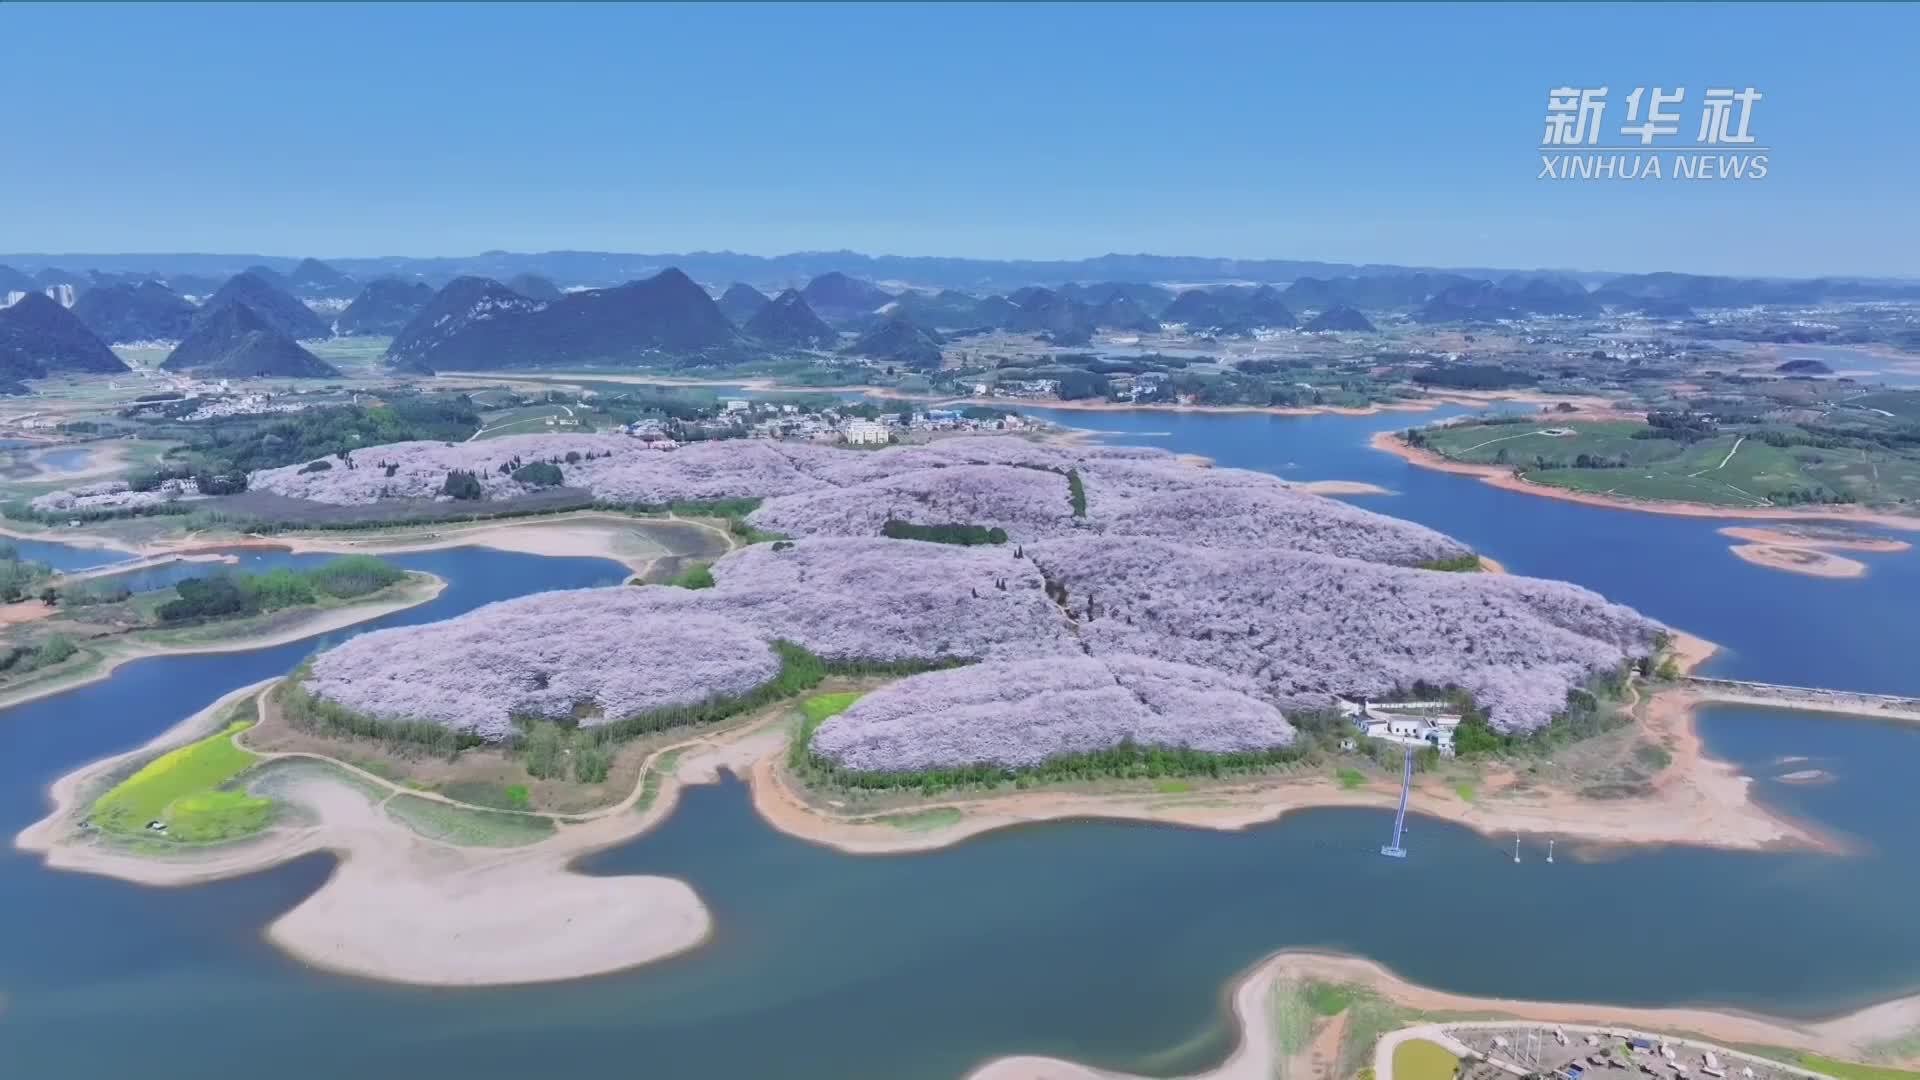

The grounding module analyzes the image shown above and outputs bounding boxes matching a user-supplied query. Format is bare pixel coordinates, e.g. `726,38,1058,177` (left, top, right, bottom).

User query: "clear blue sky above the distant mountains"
0,4,1920,277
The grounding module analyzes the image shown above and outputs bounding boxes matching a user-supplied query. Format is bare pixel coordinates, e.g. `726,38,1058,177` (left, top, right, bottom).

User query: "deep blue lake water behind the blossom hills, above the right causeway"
1027,399,1920,694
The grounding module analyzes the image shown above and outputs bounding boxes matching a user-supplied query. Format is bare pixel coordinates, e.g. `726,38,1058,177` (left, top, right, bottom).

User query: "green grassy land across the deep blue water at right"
1425,421,1920,507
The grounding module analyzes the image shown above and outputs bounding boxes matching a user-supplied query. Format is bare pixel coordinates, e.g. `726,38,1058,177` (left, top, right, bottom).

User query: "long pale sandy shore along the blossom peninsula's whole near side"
19,622,1837,986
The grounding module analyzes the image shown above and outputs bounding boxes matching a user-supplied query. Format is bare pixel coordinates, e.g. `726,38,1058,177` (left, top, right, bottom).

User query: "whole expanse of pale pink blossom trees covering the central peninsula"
280,428,1659,771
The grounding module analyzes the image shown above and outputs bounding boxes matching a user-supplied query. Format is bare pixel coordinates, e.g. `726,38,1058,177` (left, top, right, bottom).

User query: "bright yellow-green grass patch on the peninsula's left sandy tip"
90,721,273,842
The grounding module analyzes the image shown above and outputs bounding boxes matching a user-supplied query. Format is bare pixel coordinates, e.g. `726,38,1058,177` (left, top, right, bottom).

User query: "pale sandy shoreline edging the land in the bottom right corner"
968,951,1920,1080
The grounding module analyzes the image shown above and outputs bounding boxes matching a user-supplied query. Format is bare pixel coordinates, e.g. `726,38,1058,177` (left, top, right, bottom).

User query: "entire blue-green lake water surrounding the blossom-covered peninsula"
0,413,1920,1080
